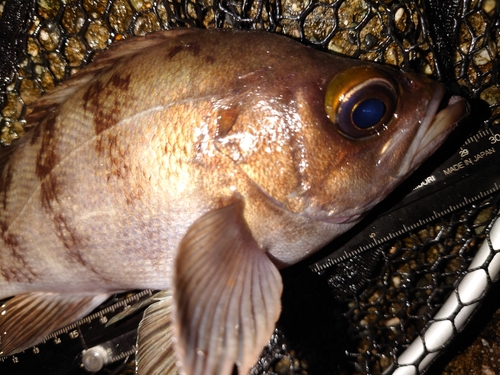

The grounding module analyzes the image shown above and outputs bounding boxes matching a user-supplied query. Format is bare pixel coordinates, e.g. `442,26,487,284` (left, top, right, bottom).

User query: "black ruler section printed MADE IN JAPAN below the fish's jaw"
309,128,500,274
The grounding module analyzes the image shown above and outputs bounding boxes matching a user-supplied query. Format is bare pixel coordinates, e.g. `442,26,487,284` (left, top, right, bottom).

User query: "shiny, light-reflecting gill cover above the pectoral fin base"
215,103,305,209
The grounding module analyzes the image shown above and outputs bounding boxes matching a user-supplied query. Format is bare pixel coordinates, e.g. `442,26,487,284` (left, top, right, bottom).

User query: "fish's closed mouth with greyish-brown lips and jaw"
392,86,470,178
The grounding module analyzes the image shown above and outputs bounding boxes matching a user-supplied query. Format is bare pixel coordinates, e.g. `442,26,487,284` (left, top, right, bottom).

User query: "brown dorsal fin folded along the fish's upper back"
25,29,193,130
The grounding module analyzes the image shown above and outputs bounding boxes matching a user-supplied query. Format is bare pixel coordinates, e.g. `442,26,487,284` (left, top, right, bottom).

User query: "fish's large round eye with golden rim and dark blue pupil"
325,67,398,139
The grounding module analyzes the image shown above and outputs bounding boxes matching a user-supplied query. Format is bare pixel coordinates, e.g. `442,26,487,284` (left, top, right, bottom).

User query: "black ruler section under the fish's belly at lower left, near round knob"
0,290,152,375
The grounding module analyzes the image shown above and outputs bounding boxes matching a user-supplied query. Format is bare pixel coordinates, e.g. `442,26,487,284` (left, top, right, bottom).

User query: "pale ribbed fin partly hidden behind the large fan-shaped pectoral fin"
136,292,179,375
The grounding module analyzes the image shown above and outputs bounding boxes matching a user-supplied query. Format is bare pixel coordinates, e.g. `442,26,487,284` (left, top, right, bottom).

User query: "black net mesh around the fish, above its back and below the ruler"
0,0,500,374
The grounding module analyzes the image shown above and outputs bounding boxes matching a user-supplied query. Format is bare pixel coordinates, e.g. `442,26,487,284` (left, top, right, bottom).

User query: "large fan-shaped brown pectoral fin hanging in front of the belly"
174,200,283,375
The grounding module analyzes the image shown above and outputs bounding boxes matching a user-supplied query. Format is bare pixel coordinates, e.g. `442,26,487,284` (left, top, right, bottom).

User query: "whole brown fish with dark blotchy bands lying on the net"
0,29,468,375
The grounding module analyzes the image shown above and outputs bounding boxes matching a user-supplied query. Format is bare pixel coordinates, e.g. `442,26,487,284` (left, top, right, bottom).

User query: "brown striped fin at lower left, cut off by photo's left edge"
0,293,109,356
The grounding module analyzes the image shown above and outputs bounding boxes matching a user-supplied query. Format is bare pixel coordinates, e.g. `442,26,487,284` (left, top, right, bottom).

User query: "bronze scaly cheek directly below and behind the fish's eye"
286,90,377,214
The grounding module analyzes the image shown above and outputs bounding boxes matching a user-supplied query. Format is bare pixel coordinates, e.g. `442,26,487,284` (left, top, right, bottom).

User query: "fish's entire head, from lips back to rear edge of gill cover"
218,59,468,241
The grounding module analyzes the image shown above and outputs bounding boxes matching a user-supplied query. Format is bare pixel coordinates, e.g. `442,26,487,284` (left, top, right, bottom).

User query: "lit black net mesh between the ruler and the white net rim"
338,197,498,374
